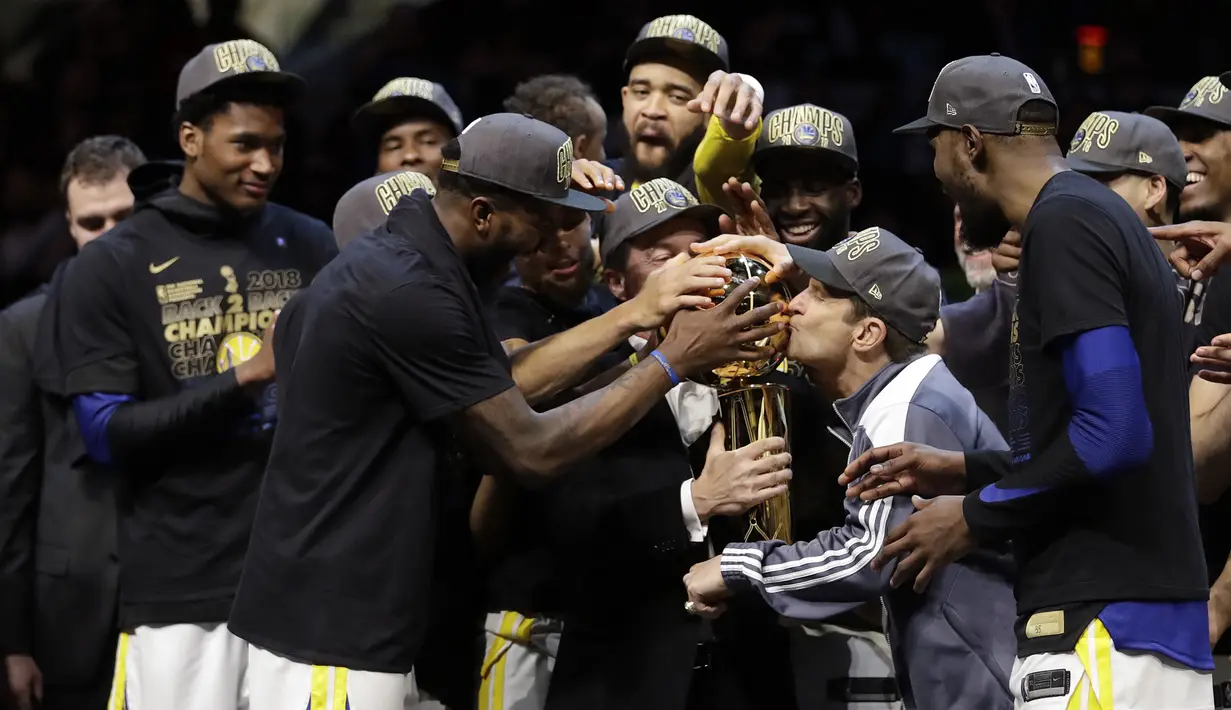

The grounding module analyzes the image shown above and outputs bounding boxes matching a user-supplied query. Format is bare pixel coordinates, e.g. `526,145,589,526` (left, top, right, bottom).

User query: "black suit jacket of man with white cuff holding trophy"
547,388,794,710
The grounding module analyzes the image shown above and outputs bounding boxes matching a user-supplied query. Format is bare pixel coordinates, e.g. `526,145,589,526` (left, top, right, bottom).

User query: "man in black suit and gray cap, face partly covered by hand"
545,177,794,710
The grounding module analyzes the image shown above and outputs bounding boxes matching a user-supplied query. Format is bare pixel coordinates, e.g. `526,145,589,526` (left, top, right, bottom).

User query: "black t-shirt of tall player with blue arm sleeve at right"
989,172,1208,614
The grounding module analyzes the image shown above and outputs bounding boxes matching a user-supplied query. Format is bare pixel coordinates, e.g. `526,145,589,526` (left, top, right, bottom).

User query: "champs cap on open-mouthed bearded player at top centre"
624,15,731,82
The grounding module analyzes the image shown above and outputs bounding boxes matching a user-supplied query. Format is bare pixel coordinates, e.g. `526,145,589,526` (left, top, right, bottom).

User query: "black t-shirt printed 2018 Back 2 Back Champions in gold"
58,189,337,626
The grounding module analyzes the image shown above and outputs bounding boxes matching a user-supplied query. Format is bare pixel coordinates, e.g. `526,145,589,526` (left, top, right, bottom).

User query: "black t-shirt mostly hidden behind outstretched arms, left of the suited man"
486,287,619,618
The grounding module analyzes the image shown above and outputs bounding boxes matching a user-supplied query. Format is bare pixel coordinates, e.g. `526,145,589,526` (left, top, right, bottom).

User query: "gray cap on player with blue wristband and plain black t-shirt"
441,113,609,212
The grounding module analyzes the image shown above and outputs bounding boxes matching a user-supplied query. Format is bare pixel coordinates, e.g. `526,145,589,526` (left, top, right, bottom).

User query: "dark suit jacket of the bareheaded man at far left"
0,267,118,685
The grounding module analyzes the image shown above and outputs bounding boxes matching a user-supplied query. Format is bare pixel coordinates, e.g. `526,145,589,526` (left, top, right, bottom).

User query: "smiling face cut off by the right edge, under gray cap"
1172,118,1231,221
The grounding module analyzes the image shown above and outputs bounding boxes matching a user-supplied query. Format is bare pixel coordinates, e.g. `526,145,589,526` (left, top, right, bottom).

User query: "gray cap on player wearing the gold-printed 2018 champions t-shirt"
175,39,307,110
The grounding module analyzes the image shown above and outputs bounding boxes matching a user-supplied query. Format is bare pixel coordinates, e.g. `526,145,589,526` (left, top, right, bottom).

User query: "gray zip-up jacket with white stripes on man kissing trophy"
721,354,1017,710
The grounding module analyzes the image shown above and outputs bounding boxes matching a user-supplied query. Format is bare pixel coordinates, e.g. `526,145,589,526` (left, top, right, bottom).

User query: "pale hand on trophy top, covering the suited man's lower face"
632,253,731,331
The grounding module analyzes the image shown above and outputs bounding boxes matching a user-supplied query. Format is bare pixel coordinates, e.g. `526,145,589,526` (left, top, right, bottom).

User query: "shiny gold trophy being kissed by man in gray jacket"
699,252,794,543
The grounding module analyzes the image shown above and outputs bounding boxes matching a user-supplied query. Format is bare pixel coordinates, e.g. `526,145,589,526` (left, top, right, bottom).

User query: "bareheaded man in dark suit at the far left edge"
0,135,145,710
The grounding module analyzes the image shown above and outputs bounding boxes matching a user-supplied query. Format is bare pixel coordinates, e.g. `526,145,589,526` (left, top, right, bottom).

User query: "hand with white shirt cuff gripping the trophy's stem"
692,422,792,522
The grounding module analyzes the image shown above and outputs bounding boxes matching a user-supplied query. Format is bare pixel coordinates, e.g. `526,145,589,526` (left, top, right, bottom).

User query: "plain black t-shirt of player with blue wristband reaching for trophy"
230,194,513,673
